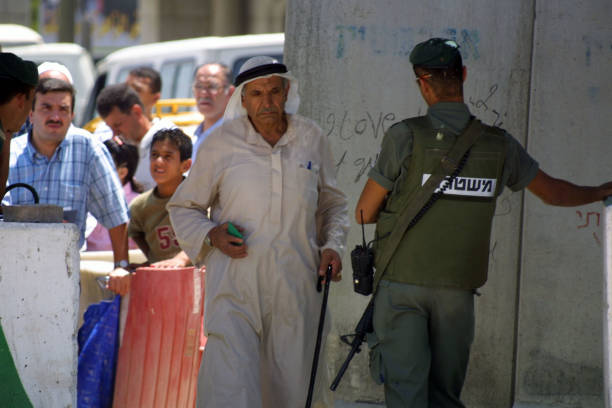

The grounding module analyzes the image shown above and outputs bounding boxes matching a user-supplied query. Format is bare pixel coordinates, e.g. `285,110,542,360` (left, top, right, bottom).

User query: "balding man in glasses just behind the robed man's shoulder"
191,63,234,162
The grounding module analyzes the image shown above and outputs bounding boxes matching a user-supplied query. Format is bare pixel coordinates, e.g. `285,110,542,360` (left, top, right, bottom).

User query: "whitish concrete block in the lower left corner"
0,222,79,408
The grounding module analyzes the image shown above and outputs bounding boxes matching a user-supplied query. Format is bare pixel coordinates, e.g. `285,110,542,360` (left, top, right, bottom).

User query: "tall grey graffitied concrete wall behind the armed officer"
285,0,612,407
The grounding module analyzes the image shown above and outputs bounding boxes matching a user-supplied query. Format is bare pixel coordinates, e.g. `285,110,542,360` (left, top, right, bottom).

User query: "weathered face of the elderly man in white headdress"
242,75,289,129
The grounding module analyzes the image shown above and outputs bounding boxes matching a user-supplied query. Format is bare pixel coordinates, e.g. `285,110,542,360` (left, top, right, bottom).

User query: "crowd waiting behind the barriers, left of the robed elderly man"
0,53,233,274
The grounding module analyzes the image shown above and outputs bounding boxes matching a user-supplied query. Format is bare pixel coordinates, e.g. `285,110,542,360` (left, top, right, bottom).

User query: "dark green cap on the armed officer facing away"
410,38,462,69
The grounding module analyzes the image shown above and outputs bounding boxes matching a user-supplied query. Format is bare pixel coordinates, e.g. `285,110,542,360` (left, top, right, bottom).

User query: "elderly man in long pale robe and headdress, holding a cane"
168,57,349,408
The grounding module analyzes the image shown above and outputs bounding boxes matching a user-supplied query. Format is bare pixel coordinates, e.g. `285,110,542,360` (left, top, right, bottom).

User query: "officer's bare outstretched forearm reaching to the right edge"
527,170,612,207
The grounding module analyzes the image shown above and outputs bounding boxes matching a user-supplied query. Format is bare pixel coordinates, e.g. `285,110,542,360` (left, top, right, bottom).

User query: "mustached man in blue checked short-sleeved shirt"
5,78,128,280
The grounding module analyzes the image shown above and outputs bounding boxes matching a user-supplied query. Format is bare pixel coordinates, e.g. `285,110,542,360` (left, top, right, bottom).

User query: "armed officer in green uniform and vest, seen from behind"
355,38,612,408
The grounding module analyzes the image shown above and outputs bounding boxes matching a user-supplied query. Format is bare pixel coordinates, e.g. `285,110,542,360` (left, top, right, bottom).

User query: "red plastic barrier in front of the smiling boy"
113,267,204,408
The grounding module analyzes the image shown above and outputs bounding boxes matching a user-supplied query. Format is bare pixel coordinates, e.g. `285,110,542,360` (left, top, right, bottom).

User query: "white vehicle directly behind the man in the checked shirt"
4,43,95,123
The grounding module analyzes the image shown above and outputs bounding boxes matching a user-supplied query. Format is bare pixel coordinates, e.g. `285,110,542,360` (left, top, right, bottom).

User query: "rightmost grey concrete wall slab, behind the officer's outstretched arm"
516,0,612,407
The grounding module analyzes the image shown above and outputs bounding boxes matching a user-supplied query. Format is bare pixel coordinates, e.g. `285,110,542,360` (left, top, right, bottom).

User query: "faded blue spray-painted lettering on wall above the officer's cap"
335,24,480,60
